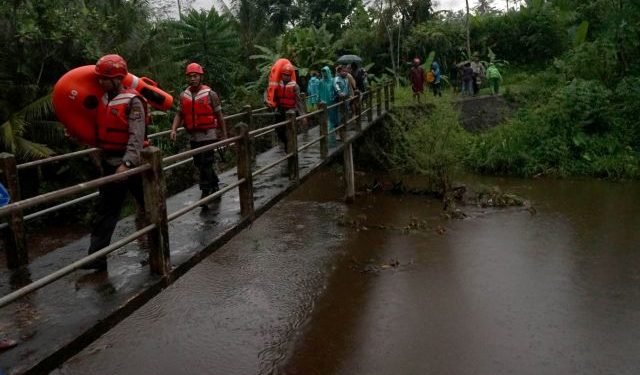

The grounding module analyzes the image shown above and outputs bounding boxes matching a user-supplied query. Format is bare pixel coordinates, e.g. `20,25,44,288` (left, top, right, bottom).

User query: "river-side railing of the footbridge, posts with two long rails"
0,85,390,307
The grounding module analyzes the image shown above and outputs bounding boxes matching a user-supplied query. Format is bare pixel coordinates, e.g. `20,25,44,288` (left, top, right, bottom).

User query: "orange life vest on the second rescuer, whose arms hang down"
180,85,218,131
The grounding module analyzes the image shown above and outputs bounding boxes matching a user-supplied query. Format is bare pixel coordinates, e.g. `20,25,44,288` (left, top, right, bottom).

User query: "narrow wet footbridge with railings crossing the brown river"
0,83,394,374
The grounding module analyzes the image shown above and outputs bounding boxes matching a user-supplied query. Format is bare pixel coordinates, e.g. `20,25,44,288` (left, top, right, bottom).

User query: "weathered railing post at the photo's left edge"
0,152,29,269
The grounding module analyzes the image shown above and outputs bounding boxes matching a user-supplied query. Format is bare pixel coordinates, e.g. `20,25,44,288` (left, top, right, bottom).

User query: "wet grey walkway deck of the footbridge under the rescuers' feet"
0,106,385,374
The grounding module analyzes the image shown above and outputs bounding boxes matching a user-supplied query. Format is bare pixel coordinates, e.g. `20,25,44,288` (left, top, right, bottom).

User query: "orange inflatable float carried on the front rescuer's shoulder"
53,65,173,146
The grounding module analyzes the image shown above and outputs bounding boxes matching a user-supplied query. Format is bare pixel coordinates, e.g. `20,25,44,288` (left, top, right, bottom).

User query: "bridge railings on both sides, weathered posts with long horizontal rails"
0,83,393,307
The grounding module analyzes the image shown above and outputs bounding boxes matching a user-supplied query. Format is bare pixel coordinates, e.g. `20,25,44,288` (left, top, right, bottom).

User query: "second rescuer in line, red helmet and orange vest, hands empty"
171,63,227,209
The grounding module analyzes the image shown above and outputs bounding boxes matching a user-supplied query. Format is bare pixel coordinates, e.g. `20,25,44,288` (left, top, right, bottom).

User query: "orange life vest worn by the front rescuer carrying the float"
96,89,148,151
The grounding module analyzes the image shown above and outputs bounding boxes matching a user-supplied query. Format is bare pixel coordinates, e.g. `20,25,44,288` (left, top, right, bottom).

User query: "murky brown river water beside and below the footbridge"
53,169,640,375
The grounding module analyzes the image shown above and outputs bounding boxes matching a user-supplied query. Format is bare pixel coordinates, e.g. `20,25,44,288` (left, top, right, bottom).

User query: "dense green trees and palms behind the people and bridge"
0,0,640,177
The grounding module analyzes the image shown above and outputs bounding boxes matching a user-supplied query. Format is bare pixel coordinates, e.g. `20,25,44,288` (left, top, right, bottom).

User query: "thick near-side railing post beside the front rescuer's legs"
141,146,171,276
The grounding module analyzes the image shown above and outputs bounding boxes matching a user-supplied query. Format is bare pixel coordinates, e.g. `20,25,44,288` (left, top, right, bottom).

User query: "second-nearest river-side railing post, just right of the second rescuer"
235,122,255,220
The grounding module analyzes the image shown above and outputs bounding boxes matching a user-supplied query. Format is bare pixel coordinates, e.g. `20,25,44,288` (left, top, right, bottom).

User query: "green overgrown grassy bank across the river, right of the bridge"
387,70,640,179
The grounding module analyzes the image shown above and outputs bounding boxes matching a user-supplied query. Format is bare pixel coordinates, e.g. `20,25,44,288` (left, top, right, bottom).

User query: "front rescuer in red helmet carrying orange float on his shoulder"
83,55,147,271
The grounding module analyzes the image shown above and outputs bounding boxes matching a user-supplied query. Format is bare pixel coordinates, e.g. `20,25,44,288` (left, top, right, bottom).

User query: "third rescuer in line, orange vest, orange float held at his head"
265,64,307,153
